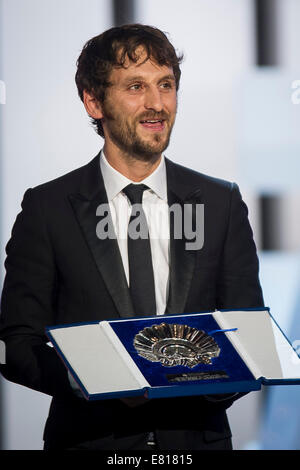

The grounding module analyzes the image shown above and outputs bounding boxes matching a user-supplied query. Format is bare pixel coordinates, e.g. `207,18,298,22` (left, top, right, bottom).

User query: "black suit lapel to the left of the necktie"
69,155,134,317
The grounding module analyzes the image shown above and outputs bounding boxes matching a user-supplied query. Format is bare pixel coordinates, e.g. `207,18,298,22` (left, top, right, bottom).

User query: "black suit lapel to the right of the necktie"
165,159,201,314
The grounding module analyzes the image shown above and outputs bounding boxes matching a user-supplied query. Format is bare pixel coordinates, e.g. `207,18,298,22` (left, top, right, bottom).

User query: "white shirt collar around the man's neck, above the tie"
100,150,168,201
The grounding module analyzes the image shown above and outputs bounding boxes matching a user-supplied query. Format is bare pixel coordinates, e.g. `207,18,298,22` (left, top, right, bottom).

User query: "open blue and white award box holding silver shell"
47,308,300,400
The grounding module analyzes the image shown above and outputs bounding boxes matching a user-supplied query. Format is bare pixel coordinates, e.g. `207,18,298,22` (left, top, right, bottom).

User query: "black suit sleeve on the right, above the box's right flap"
217,184,264,309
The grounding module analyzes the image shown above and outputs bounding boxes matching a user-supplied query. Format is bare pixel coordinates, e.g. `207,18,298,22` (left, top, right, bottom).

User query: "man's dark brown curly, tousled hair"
75,24,183,137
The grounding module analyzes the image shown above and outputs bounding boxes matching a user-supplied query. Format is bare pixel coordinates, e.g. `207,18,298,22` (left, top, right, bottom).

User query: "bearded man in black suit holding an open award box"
0,25,263,450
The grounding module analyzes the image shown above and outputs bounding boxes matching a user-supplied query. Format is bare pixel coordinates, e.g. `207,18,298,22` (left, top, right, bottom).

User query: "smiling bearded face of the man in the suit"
101,50,177,161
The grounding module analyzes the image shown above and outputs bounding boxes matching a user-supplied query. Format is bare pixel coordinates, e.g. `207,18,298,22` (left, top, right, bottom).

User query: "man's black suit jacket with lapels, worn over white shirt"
0,156,263,447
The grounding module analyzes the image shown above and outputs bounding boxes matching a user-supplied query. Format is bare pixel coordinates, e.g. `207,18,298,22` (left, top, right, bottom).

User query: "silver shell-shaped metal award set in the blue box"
133,323,221,368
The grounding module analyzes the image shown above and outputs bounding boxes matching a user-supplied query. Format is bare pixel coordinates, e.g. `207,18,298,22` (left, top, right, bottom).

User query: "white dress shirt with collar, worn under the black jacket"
100,150,170,315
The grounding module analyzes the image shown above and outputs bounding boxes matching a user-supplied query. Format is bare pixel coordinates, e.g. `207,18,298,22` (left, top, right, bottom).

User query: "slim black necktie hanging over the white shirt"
123,184,156,316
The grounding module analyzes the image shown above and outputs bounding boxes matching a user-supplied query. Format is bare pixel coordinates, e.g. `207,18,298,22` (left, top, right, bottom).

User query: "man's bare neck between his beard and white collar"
103,144,161,182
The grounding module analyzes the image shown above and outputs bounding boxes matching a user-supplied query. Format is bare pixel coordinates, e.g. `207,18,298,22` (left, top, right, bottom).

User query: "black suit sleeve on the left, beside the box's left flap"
0,190,71,395
